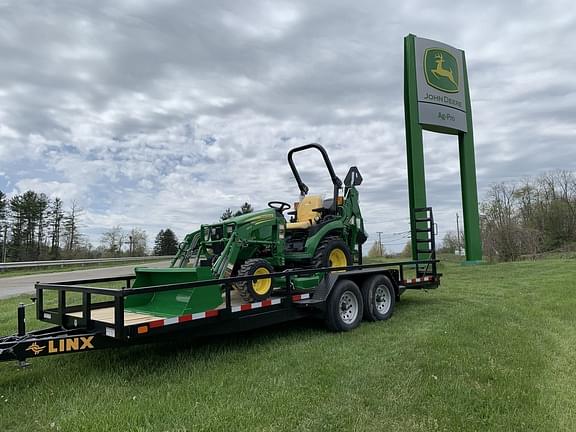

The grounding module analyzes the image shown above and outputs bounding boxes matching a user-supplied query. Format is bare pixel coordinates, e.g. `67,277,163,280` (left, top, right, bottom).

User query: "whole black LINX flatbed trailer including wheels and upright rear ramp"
0,208,442,366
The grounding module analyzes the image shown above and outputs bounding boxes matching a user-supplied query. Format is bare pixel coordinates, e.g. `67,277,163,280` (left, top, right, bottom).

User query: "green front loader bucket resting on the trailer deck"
124,267,222,317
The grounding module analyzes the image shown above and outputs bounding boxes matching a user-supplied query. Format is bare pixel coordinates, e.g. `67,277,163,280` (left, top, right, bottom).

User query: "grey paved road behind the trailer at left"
0,261,170,299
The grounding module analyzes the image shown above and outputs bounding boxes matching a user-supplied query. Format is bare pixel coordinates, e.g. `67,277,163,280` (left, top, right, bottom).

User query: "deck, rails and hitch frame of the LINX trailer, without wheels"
0,260,441,365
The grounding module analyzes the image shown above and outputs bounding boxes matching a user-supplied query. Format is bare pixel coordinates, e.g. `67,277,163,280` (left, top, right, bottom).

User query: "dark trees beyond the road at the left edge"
0,190,178,262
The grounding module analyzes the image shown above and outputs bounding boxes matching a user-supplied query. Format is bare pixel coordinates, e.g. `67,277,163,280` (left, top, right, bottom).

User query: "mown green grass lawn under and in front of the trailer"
0,259,576,432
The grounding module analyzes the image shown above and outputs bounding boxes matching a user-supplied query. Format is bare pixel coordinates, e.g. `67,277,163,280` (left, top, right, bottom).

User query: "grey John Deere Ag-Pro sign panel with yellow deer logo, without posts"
415,38,468,132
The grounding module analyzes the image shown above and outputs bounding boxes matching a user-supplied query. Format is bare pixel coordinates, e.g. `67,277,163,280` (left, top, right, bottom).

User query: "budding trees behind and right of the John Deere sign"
441,170,576,261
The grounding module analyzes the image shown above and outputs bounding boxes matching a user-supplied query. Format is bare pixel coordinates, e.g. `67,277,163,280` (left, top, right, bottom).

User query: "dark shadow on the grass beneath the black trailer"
2,293,446,380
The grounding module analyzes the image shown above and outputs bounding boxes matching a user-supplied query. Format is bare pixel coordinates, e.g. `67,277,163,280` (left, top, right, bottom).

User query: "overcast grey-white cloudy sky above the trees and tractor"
0,0,576,250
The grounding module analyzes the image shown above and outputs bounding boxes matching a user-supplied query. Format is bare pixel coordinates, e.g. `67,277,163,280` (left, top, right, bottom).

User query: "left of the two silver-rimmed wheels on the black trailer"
326,280,364,332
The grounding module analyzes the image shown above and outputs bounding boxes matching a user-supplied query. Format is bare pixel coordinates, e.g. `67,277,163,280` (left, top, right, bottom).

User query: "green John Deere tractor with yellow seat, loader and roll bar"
126,144,367,315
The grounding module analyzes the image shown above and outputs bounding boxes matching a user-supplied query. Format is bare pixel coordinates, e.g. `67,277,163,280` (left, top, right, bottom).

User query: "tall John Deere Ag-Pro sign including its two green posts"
404,35,482,262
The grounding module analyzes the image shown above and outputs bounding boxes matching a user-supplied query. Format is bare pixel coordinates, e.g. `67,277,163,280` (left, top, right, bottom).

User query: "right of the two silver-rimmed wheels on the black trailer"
362,275,396,321
